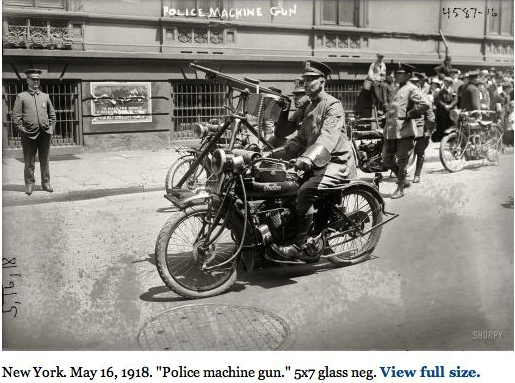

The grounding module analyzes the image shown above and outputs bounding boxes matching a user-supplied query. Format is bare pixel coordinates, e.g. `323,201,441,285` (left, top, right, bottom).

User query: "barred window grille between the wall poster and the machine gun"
172,80,228,138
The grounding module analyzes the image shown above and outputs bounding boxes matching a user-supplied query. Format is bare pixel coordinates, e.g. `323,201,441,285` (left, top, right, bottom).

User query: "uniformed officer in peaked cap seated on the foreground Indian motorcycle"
270,60,357,260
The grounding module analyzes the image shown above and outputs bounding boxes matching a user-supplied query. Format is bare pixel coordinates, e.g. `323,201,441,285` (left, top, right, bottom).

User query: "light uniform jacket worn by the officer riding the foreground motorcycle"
278,91,354,178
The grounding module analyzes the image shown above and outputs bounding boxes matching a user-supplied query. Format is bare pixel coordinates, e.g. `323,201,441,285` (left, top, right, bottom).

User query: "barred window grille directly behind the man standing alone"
4,81,83,148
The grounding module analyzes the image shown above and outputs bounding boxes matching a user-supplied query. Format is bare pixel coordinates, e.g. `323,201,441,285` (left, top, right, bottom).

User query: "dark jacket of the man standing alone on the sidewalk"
12,90,56,140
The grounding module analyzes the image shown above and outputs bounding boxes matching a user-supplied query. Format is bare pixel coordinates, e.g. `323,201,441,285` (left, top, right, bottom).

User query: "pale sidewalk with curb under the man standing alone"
2,147,183,206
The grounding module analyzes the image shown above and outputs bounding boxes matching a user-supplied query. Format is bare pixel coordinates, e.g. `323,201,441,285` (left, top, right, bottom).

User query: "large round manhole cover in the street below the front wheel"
138,304,290,351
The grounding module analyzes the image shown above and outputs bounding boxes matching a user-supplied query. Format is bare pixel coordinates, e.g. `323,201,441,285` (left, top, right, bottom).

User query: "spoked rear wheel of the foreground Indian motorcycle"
327,189,383,266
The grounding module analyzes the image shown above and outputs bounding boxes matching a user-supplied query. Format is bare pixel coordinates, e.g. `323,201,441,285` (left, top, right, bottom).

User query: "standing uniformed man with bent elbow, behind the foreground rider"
382,67,430,199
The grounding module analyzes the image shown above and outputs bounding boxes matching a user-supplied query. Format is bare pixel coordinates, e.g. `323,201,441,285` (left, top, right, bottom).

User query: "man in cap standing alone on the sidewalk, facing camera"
12,69,56,195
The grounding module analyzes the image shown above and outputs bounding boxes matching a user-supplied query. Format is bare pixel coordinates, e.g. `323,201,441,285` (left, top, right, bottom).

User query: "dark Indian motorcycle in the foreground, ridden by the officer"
155,115,398,298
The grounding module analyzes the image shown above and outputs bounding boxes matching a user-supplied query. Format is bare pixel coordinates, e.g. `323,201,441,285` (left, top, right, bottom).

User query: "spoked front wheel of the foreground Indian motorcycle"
155,205,239,298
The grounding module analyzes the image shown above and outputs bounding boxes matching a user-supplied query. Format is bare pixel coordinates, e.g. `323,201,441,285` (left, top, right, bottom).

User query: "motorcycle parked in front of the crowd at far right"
440,109,503,172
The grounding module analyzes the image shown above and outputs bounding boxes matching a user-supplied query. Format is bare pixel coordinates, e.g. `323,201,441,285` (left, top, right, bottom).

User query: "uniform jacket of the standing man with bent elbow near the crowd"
383,81,430,140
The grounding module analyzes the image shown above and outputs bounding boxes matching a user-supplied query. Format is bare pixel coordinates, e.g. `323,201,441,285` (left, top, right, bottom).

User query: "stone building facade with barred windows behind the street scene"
2,0,513,149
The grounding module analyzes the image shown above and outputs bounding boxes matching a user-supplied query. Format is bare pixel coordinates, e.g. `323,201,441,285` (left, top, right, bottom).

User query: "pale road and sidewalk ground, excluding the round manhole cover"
2,144,513,350
